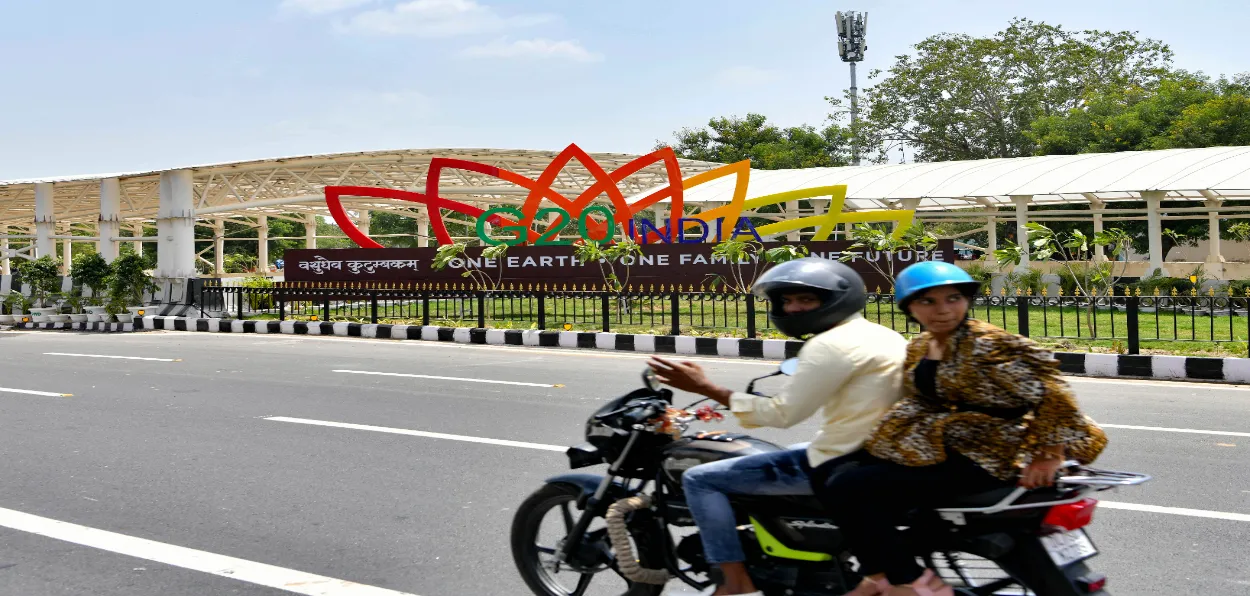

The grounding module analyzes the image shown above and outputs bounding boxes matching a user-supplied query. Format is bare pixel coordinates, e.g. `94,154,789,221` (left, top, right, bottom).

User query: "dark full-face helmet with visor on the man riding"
751,257,868,337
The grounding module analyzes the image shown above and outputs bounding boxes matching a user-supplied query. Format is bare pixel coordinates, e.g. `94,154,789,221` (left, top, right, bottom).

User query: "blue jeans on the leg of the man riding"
681,446,813,565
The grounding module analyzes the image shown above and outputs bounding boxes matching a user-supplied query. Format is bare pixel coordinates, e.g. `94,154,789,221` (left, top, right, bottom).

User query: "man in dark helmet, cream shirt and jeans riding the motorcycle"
651,257,906,596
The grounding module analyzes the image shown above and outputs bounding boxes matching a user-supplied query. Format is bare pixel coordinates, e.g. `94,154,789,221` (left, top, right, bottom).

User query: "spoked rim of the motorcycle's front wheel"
523,494,630,596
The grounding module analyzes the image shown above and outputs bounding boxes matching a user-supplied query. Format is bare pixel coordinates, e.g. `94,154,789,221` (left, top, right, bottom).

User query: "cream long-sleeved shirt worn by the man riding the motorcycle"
729,315,908,467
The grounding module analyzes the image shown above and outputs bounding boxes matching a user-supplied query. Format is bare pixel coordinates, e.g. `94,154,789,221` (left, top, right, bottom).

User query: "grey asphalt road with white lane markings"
0,332,1250,596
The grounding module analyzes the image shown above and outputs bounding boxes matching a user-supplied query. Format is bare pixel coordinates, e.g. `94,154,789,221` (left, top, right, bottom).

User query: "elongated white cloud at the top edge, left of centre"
343,0,554,37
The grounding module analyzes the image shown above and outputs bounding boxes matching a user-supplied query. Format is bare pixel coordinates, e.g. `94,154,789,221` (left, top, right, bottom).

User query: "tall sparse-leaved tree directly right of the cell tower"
830,19,1171,161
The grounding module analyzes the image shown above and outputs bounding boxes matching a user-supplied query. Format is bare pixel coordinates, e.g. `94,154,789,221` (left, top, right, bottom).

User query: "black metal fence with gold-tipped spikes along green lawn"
198,279,1250,354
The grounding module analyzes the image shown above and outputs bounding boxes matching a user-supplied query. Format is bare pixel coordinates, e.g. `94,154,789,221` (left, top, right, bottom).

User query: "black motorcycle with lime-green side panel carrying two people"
511,359,1150,596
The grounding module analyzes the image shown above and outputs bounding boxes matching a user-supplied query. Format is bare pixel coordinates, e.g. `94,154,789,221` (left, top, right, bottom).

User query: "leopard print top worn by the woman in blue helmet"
865,320,1106,481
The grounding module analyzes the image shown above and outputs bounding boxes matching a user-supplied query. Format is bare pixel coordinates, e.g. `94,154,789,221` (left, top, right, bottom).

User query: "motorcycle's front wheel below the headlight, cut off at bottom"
513,484,664,596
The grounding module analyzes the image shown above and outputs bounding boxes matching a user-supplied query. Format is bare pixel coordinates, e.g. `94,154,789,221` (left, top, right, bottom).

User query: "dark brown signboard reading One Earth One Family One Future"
284,240,955,290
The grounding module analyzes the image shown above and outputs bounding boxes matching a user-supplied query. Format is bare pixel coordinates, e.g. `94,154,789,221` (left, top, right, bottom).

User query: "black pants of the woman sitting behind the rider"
811,451,1009,585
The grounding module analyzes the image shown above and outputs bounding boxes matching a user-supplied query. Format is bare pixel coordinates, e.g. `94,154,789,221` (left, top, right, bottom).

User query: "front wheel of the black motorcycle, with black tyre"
511,482,664,596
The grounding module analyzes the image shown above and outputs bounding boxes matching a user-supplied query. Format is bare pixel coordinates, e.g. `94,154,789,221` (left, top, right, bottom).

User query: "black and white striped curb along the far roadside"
19,316,1250,384
